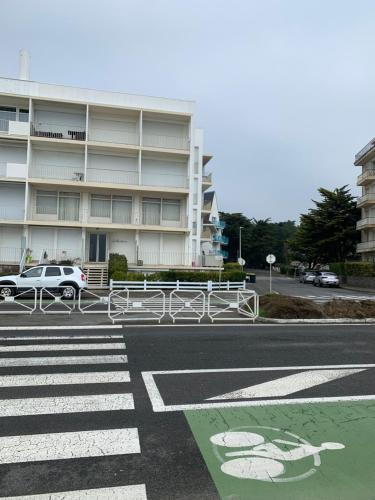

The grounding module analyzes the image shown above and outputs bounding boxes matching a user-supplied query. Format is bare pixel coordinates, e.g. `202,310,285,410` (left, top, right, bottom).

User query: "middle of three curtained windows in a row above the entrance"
90,194,132,224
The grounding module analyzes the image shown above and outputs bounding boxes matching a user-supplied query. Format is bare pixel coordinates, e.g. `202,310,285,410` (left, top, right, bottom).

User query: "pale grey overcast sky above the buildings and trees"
0,0,375,221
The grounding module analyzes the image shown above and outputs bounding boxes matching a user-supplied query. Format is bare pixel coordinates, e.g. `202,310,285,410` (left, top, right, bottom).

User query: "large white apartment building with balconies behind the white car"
0,58,226,282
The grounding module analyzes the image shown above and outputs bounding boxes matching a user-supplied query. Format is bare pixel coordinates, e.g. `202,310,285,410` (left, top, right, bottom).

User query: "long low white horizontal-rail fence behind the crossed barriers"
109,280,246,292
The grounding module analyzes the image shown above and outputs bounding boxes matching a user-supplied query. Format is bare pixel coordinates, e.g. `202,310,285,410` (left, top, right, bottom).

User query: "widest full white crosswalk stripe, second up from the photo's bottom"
0,428,141,464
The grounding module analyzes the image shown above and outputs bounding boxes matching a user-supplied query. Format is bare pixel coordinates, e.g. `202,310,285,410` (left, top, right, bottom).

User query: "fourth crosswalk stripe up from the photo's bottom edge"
0,371,130,386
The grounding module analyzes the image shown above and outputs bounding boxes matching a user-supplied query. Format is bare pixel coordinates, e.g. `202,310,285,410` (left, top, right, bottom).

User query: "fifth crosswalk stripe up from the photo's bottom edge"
0,355,128,368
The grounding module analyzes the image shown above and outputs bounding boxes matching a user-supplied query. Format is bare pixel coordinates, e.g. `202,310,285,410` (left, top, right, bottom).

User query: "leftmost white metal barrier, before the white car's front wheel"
0,285,38,314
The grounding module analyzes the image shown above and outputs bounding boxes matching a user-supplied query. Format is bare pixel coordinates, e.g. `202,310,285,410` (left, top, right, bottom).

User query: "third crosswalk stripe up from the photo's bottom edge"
0,393,134,416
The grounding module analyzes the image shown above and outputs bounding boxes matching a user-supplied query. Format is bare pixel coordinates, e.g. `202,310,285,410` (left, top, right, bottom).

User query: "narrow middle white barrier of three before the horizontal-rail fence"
169,290,206,323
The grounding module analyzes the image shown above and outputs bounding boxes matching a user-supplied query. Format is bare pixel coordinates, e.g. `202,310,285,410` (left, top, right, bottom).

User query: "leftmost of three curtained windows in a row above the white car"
36,190,80,221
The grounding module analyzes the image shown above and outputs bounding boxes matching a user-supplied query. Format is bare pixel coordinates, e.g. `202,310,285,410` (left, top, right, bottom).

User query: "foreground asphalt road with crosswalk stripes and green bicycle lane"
0,325,375,500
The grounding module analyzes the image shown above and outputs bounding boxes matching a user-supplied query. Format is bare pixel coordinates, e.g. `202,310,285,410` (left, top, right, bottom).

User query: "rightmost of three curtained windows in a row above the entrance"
142,198,181,226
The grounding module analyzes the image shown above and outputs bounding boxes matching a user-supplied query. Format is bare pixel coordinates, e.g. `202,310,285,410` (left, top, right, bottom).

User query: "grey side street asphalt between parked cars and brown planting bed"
248,270,375,302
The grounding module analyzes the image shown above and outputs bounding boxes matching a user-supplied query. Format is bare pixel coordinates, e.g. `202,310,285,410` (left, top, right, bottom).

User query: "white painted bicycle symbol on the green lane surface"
210,426,345,482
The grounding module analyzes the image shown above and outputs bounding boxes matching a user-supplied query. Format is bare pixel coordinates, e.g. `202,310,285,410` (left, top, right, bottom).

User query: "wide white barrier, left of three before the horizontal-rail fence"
108,289,165,323
